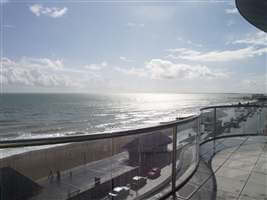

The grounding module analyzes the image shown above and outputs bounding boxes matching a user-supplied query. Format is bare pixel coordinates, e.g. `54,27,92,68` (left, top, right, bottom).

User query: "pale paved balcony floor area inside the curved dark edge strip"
212,137,267,200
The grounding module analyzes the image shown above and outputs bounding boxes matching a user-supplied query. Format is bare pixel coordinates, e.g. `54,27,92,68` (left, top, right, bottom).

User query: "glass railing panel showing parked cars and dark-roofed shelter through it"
112,129,173,199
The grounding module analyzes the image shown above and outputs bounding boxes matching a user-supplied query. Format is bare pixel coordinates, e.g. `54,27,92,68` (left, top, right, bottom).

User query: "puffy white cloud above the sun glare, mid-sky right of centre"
116,59,227,80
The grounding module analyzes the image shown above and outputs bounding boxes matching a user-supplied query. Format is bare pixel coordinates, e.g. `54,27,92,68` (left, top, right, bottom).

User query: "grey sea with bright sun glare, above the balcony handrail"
0,93,250,140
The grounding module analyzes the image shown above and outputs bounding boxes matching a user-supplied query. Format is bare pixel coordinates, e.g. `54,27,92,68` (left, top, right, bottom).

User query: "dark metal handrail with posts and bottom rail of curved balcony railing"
0,104,265,200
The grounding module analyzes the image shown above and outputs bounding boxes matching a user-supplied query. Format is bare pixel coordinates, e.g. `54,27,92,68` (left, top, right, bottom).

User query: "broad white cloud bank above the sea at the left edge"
1,57,82,88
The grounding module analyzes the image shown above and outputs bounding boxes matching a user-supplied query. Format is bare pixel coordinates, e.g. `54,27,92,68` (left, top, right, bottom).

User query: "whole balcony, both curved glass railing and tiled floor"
0,102,267,200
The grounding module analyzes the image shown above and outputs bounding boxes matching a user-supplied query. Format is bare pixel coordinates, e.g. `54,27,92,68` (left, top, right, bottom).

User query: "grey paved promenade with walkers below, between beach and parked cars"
32,152,134,200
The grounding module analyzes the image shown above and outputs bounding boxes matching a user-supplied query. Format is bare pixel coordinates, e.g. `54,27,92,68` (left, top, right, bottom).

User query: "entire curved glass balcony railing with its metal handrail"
0,104,264,200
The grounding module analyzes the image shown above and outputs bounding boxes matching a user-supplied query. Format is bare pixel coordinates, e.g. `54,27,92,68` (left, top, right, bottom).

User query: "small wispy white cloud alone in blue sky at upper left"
29,4,68,18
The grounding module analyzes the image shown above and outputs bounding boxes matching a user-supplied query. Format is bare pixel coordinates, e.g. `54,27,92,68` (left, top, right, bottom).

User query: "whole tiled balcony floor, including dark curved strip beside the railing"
177,136,267,200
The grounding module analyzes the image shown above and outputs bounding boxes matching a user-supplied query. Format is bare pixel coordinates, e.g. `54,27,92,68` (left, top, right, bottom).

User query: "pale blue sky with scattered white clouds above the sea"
0,0,267,93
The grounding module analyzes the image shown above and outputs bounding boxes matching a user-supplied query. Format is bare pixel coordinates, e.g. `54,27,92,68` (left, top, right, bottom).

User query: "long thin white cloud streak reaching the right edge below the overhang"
167,47,267,62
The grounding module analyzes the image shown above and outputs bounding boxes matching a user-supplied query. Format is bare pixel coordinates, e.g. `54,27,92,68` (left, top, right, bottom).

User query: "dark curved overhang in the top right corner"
235,0,267,32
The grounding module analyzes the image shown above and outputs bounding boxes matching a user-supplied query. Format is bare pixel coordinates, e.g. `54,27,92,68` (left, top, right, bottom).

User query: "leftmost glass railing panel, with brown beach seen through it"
1,139,113,200
